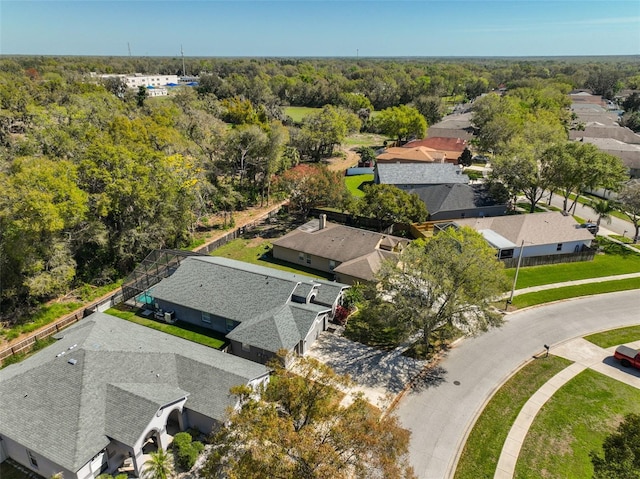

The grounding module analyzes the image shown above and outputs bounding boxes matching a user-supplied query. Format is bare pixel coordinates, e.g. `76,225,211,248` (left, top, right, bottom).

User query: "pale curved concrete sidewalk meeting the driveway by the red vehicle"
493,338,640,479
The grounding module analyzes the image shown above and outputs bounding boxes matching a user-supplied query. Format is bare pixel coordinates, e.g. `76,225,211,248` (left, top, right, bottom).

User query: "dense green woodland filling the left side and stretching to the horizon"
0,57,640,322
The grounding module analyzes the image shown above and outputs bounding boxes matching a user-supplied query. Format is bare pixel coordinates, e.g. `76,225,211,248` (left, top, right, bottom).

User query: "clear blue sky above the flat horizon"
0,0,640,57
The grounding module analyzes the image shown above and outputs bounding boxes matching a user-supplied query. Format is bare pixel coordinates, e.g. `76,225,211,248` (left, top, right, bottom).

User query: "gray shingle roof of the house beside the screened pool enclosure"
149,256,348,353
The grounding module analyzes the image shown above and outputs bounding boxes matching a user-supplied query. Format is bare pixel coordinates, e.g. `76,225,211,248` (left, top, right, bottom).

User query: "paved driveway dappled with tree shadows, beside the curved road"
306,331,424,409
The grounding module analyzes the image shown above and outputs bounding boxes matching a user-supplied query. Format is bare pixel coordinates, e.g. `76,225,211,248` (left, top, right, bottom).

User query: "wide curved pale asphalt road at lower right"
396,290,640,479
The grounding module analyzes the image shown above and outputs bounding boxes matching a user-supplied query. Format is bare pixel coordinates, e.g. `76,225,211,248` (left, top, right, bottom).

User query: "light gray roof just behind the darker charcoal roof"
376,163,469,185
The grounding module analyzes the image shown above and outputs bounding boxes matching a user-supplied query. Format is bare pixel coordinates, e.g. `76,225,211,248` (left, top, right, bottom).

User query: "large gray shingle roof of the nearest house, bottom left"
0,313,267,471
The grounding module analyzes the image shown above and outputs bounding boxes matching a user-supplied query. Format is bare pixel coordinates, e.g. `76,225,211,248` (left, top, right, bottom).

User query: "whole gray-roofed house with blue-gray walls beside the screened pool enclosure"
147,256,348,363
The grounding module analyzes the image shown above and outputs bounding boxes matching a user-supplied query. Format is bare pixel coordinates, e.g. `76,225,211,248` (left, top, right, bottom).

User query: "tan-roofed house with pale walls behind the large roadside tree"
453,212,593,259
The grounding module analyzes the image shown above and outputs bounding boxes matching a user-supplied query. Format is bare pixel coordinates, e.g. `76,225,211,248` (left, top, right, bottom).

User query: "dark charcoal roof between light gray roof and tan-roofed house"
407,183,508,215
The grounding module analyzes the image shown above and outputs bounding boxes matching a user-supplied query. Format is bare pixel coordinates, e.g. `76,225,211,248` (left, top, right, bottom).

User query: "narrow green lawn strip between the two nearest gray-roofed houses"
106,305,226,349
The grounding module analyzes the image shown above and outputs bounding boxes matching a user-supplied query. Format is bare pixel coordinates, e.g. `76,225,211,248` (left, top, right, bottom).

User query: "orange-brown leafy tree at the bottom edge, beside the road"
203,358,415,479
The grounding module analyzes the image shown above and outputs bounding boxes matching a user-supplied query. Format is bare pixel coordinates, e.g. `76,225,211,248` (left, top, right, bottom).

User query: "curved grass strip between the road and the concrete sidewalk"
455,355,571,479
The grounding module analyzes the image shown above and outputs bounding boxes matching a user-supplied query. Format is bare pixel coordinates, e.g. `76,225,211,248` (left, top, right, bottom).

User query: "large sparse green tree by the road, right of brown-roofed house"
363,227,507,347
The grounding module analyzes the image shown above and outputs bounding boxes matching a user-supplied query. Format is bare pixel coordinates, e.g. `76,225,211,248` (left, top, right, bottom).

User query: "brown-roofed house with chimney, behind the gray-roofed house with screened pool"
273,215,409,284
